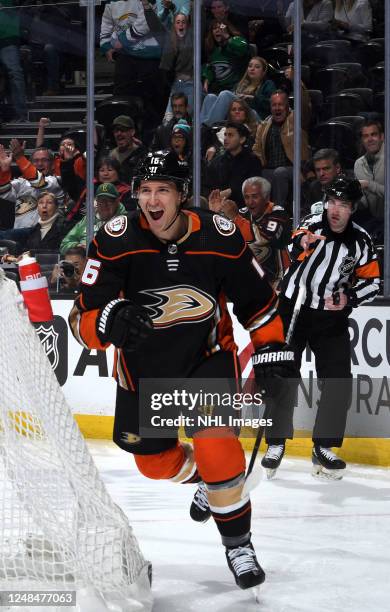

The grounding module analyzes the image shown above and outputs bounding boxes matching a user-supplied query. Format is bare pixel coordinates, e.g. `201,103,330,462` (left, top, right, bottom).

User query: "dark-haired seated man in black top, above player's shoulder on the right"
204,121,262,207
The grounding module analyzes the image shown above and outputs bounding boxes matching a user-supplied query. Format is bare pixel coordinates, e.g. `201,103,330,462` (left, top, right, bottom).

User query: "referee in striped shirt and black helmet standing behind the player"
262,177,379,479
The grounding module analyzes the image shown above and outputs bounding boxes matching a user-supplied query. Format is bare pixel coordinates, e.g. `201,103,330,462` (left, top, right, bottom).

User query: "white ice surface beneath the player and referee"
88,441,390,612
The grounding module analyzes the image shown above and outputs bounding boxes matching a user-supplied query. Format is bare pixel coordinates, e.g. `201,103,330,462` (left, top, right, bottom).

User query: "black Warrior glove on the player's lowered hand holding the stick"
252,342,299,397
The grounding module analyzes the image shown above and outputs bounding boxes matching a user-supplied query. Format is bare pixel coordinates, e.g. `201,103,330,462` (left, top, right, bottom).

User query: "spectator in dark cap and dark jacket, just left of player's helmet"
110,115,147,183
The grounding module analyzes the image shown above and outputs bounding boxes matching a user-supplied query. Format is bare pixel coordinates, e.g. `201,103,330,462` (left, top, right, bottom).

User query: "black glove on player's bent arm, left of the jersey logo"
97,299,153,351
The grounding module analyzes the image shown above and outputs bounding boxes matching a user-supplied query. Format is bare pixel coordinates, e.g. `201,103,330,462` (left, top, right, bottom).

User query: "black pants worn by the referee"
267,298,352,448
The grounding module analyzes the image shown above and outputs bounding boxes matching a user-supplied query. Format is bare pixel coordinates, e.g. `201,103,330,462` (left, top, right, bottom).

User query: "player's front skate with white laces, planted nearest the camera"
226,541,265,600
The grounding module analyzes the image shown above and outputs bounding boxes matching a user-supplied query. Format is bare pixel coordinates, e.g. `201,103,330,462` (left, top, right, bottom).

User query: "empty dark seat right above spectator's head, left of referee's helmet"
310,121,360,169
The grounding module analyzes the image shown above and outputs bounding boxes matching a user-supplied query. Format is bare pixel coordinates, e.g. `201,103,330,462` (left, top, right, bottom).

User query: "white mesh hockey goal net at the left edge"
0,269,152,612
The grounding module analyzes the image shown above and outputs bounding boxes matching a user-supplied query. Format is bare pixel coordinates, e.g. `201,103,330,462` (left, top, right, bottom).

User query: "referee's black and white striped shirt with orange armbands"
281,212,379,310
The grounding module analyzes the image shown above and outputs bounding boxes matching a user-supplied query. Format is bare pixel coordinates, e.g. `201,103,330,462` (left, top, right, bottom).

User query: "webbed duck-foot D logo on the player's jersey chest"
141,285,215,327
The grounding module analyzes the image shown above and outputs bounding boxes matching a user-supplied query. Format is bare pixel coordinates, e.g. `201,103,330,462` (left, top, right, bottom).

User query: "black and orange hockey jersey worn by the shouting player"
70,211,284,389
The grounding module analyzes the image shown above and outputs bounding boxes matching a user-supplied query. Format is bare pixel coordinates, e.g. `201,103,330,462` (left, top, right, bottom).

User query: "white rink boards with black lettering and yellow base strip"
47,299,390,466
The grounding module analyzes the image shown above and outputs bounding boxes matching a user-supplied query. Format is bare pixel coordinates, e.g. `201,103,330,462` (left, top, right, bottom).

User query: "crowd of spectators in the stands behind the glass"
0,0,385,291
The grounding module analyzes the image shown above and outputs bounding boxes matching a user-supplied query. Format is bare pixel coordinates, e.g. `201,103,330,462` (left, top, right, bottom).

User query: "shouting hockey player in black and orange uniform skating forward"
70,151,294,589
